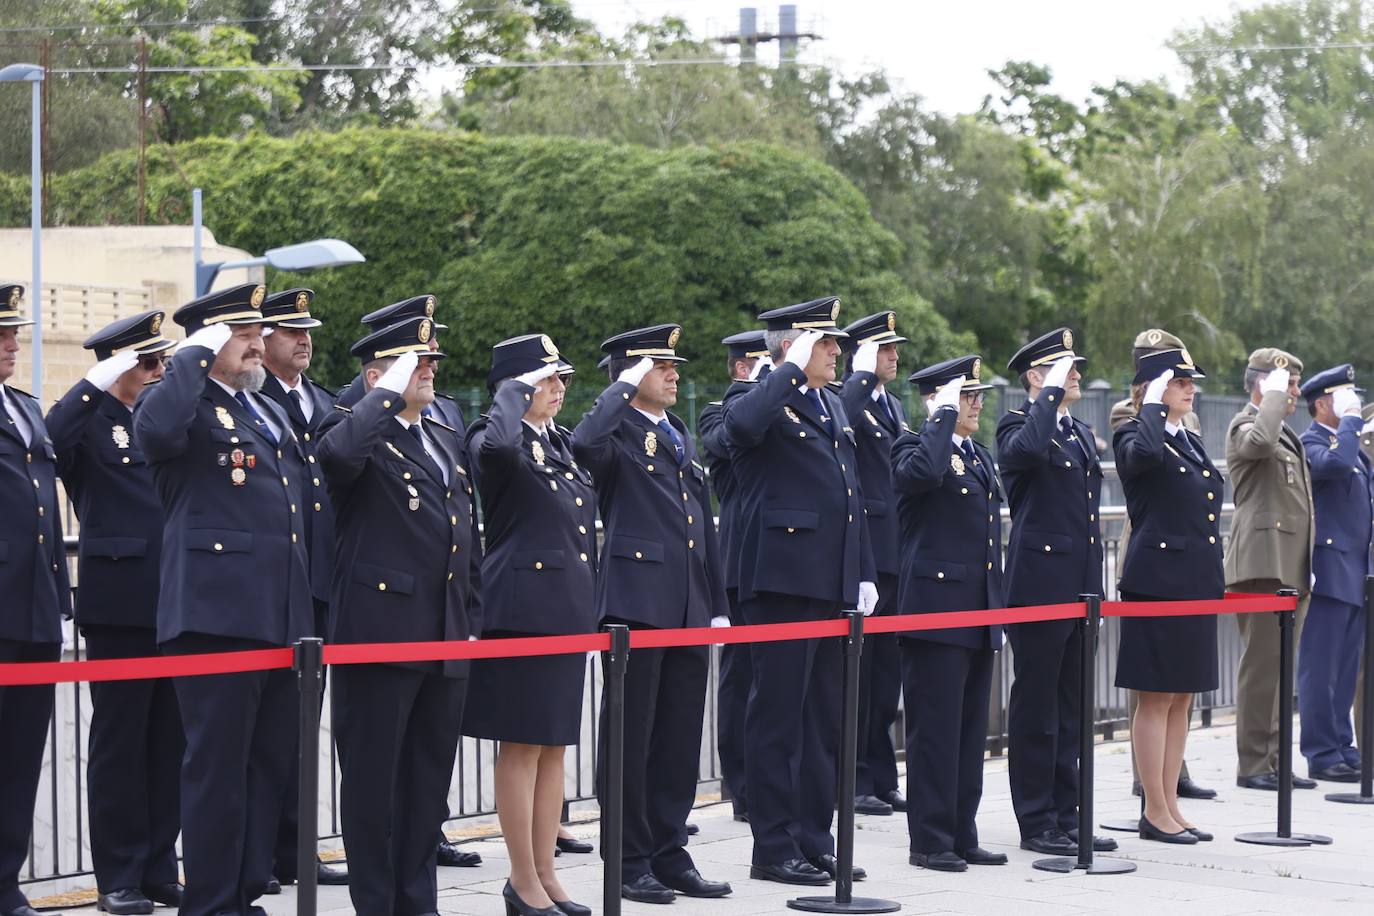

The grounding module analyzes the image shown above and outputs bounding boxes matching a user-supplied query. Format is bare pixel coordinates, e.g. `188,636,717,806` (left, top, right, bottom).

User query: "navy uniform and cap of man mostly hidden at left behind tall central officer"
697,331,768,817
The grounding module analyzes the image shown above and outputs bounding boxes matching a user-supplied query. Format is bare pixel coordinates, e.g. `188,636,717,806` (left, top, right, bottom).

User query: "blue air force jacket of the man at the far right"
1303,416,1374,606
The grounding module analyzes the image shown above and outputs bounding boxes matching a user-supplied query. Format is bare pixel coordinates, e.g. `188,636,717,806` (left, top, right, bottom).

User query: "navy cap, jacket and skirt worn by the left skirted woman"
463,334,596,747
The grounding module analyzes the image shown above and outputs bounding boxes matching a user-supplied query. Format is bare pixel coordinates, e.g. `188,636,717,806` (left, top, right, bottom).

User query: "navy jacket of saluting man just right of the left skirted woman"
573,382,730,629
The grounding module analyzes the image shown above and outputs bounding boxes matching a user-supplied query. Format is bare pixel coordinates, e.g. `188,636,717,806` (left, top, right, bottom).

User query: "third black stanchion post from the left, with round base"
787,611,901,913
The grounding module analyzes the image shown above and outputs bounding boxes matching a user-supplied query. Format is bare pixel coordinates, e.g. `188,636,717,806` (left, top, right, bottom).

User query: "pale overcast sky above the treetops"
560,0,1261,114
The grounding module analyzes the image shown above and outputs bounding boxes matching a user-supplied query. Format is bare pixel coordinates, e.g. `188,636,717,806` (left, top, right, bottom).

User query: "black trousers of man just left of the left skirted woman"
334,665,467,916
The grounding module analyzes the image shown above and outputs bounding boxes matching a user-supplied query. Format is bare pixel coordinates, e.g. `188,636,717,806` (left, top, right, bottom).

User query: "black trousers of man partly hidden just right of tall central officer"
855,574,901,797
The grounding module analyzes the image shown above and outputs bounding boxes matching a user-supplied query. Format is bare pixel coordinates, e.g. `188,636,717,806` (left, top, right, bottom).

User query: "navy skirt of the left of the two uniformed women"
463,630,587,747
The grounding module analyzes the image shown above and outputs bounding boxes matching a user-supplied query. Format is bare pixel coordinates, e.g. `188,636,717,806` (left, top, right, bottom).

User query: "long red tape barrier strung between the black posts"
0,593,1297,687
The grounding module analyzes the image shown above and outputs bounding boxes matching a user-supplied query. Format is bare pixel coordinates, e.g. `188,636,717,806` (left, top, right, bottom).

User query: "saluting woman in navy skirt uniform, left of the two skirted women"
463,334,596,916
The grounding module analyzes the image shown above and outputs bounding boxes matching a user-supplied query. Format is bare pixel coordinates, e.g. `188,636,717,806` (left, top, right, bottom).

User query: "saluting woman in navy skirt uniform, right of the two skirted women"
1113,349,1226,843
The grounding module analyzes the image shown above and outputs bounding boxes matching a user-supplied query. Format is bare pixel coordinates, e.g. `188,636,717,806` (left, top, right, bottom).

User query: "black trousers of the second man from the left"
81,626,185,894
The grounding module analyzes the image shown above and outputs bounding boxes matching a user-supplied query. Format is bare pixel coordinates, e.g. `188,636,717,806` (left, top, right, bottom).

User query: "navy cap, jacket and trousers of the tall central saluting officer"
725,297,877,871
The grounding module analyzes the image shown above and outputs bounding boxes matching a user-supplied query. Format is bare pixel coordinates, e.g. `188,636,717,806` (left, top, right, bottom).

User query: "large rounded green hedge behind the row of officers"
0,129,973,389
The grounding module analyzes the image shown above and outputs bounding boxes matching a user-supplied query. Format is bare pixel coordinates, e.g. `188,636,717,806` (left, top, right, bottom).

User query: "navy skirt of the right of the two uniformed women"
1116,592,1220,694
